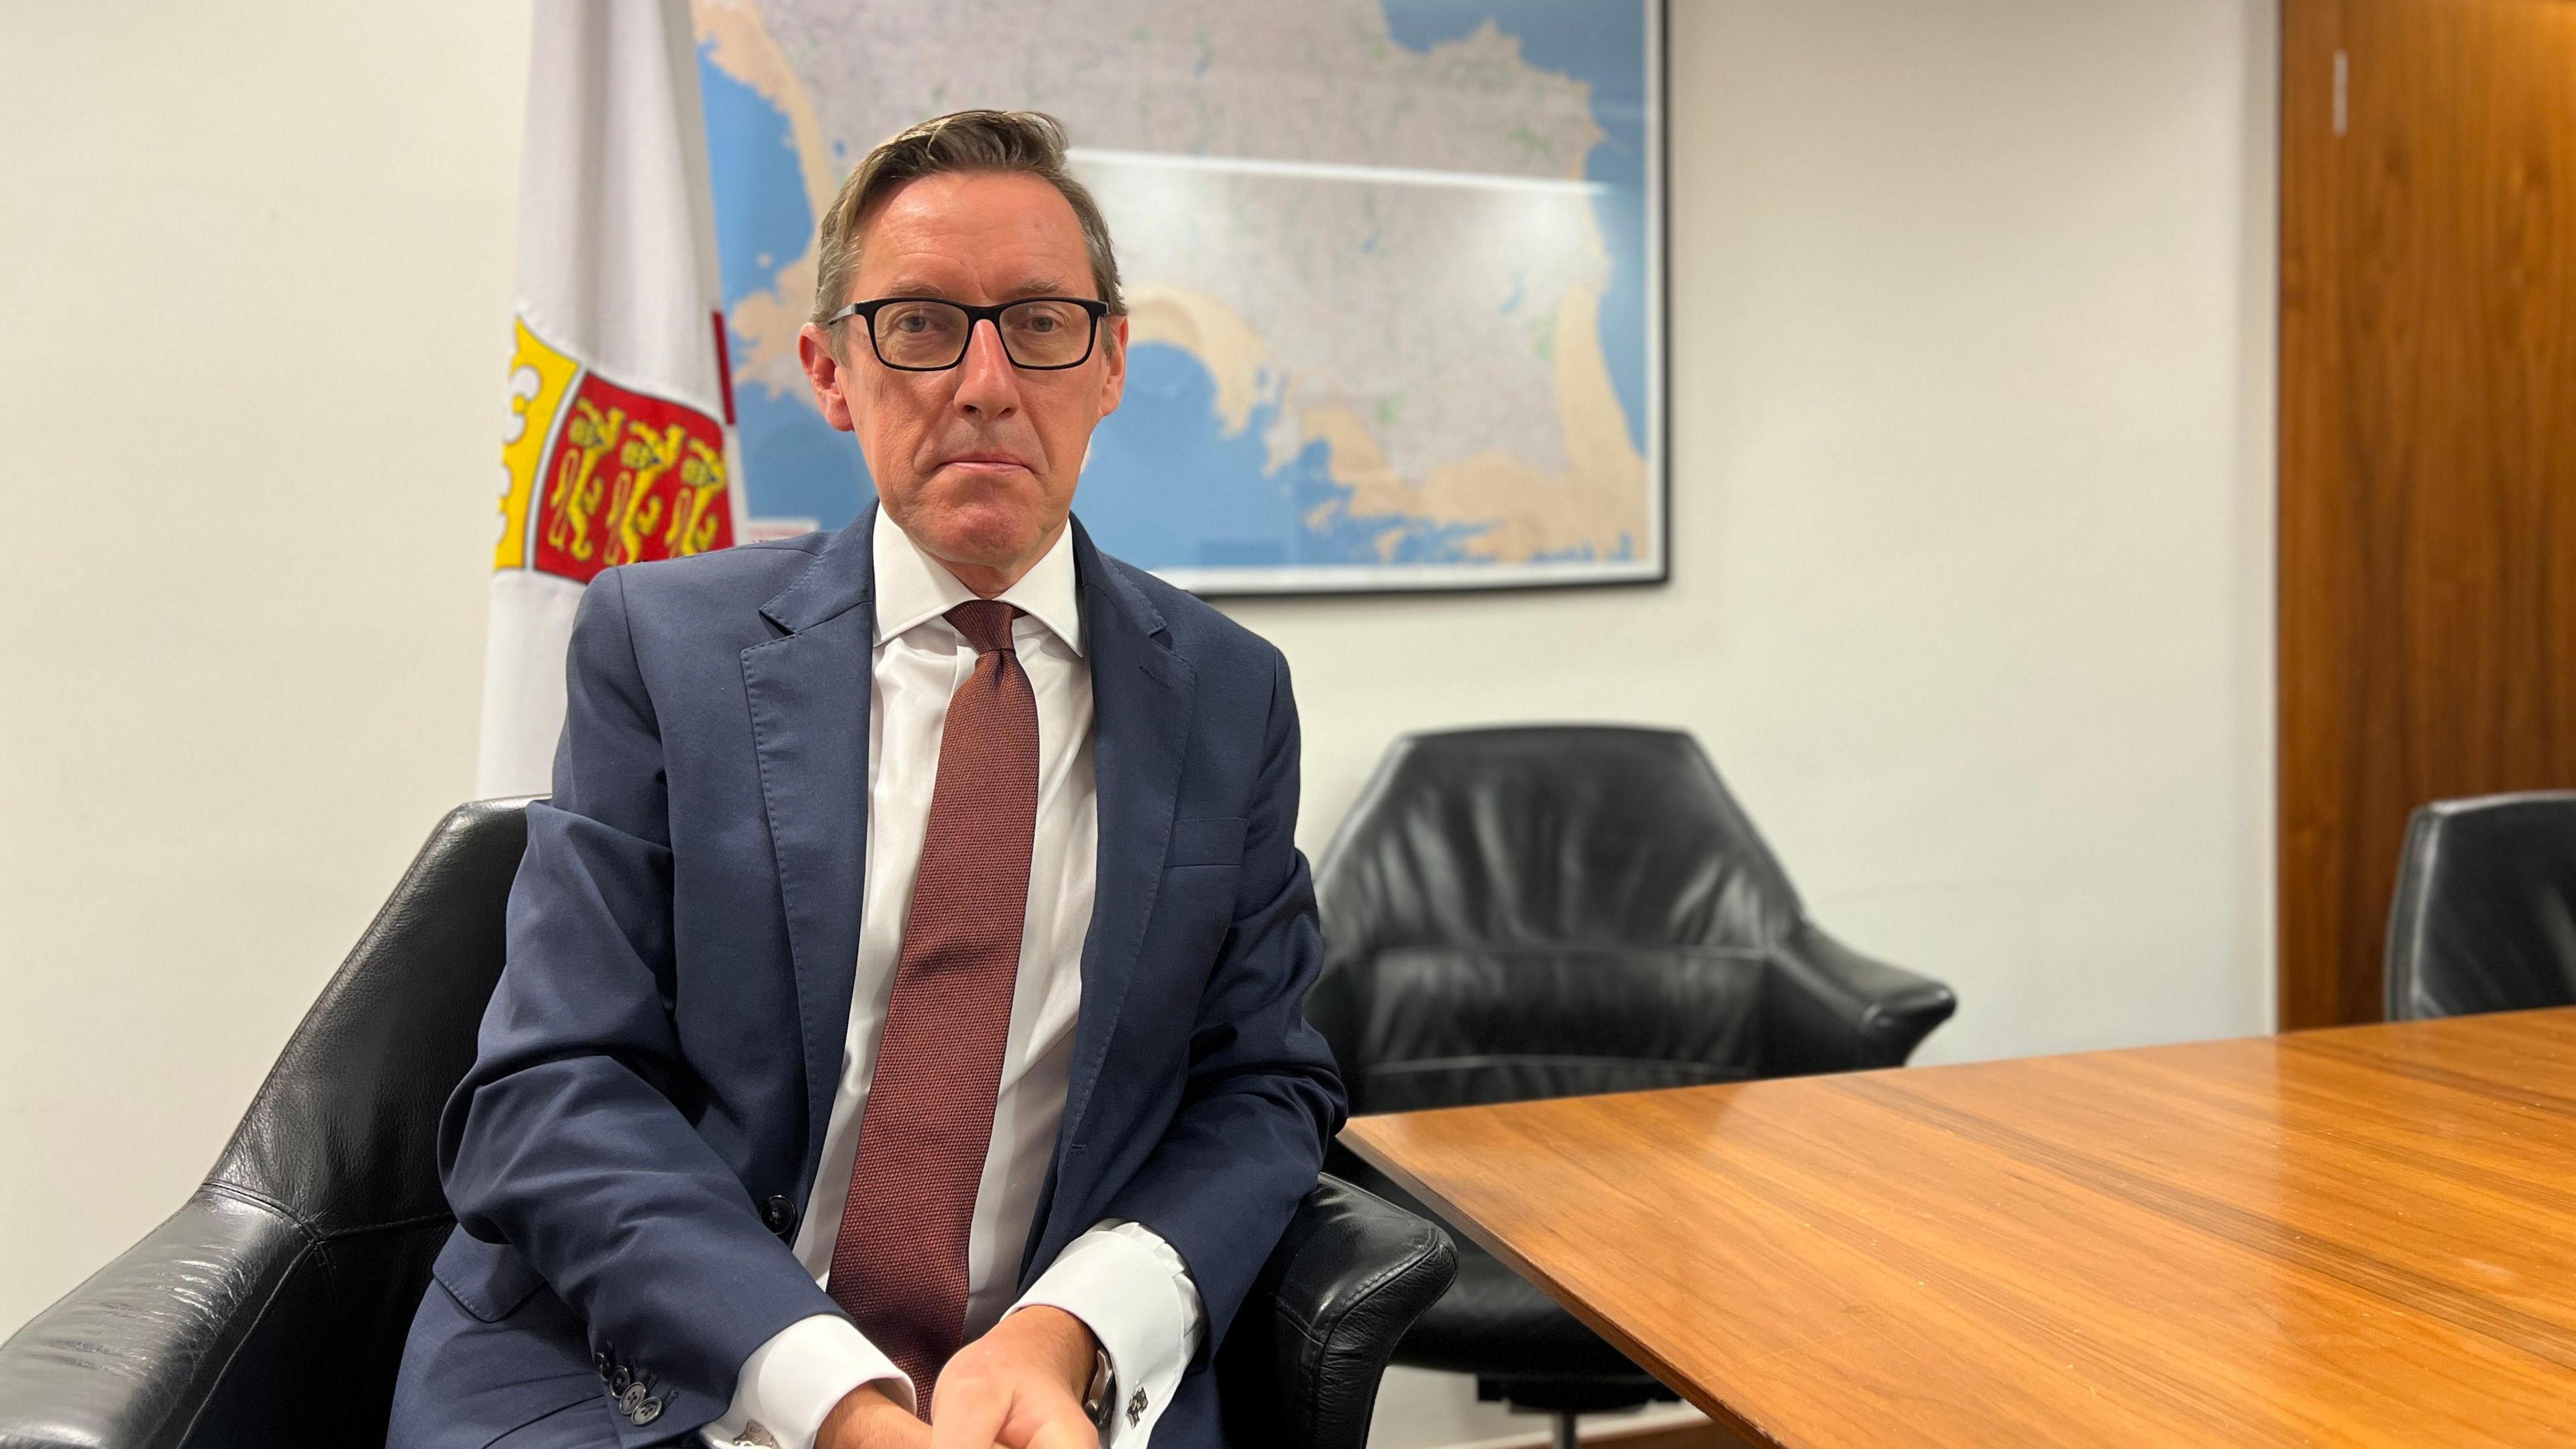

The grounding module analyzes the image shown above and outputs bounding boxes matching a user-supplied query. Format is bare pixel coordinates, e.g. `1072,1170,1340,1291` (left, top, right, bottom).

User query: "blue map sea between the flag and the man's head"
698,46,876,529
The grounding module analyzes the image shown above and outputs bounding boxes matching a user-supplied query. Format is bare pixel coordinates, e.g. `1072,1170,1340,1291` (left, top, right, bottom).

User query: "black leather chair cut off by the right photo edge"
2385,792,2576,1021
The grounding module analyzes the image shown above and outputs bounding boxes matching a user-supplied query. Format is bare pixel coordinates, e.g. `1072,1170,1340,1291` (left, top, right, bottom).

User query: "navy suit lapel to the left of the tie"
742,508,876,1175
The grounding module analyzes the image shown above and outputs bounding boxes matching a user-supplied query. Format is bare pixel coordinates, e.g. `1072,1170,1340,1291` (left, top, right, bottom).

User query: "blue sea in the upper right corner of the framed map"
1383,0,1646,453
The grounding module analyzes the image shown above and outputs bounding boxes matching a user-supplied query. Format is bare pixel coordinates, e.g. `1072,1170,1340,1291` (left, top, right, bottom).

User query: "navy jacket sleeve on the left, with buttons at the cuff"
438,570,840,1444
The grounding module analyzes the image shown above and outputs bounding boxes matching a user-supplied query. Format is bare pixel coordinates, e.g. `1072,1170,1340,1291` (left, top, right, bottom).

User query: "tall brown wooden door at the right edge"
2279,0,2576,1029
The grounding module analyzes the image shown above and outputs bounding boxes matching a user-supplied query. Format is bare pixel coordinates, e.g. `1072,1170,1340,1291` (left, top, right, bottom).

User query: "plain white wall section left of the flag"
0,0,528,1330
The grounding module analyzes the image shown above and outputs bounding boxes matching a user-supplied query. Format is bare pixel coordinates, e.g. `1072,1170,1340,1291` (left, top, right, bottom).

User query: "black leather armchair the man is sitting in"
0,799,1456,1449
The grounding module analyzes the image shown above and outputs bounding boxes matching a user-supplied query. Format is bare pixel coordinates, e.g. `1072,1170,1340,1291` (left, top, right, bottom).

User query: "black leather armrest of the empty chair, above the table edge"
1762,920,1957,1075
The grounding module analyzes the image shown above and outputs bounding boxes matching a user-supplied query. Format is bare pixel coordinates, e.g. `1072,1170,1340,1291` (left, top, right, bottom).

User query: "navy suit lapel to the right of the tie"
1022,521,1198,1279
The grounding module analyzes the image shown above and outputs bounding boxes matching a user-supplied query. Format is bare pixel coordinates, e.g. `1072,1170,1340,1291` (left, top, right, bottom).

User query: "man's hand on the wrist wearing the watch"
930,1305,1100,1449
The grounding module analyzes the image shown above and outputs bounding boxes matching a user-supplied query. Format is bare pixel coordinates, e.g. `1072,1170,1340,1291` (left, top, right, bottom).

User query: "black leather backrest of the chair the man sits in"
206,799,528,1444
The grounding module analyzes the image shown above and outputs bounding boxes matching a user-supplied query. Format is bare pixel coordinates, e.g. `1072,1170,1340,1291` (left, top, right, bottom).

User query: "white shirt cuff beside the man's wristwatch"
1012,1220,1205,1449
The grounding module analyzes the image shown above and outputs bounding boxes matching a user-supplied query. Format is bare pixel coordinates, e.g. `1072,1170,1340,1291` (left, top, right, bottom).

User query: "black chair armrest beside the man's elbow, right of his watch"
1216,1176,1458,1449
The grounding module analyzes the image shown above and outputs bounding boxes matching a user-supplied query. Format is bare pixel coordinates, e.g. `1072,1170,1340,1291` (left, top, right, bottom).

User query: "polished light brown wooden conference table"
1344,1008,2576,1449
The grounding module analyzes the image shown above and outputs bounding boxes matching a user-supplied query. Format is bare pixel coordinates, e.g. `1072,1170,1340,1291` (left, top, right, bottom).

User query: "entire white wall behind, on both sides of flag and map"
0,0,2275,1444
